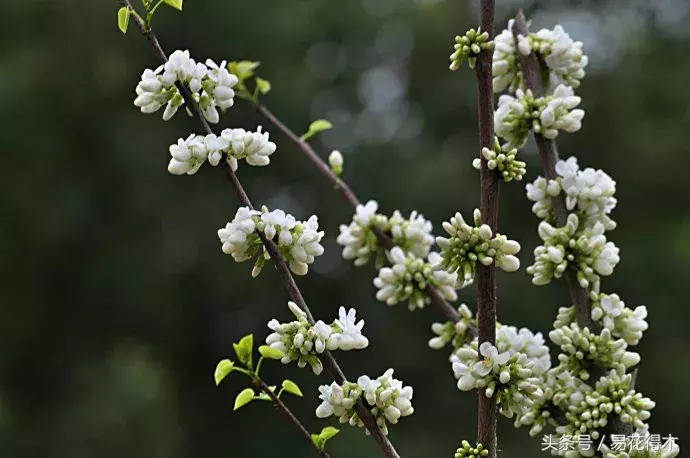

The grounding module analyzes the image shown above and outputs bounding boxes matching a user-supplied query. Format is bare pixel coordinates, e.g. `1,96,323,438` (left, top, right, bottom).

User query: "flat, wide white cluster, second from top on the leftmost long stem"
168,126,276,175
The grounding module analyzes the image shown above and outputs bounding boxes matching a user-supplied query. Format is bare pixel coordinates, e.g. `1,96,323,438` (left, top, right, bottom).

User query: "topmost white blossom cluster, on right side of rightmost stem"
518,25,589,89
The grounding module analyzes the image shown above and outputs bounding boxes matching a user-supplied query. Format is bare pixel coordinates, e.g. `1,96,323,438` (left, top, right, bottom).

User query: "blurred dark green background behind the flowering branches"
0,0,690,458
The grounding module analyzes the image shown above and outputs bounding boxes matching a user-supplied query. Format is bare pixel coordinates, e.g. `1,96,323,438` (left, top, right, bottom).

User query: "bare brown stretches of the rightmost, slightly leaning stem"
512,10,601,332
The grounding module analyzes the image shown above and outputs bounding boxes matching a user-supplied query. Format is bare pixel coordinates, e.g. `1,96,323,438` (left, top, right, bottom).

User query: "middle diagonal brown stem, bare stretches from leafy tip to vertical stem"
255,103,462,326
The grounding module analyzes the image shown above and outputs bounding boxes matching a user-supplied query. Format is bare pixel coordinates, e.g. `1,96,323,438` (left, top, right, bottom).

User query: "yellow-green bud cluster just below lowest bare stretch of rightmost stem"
549,323,640,381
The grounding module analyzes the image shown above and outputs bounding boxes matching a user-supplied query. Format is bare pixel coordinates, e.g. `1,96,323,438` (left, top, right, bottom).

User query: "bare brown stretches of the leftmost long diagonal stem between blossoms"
119,0,399,458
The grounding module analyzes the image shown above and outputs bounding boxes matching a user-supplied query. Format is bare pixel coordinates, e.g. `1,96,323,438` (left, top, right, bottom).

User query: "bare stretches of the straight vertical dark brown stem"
476,0,499,458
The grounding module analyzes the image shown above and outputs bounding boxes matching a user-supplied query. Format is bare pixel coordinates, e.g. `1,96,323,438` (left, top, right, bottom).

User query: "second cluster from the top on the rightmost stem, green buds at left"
494,85,585,151
